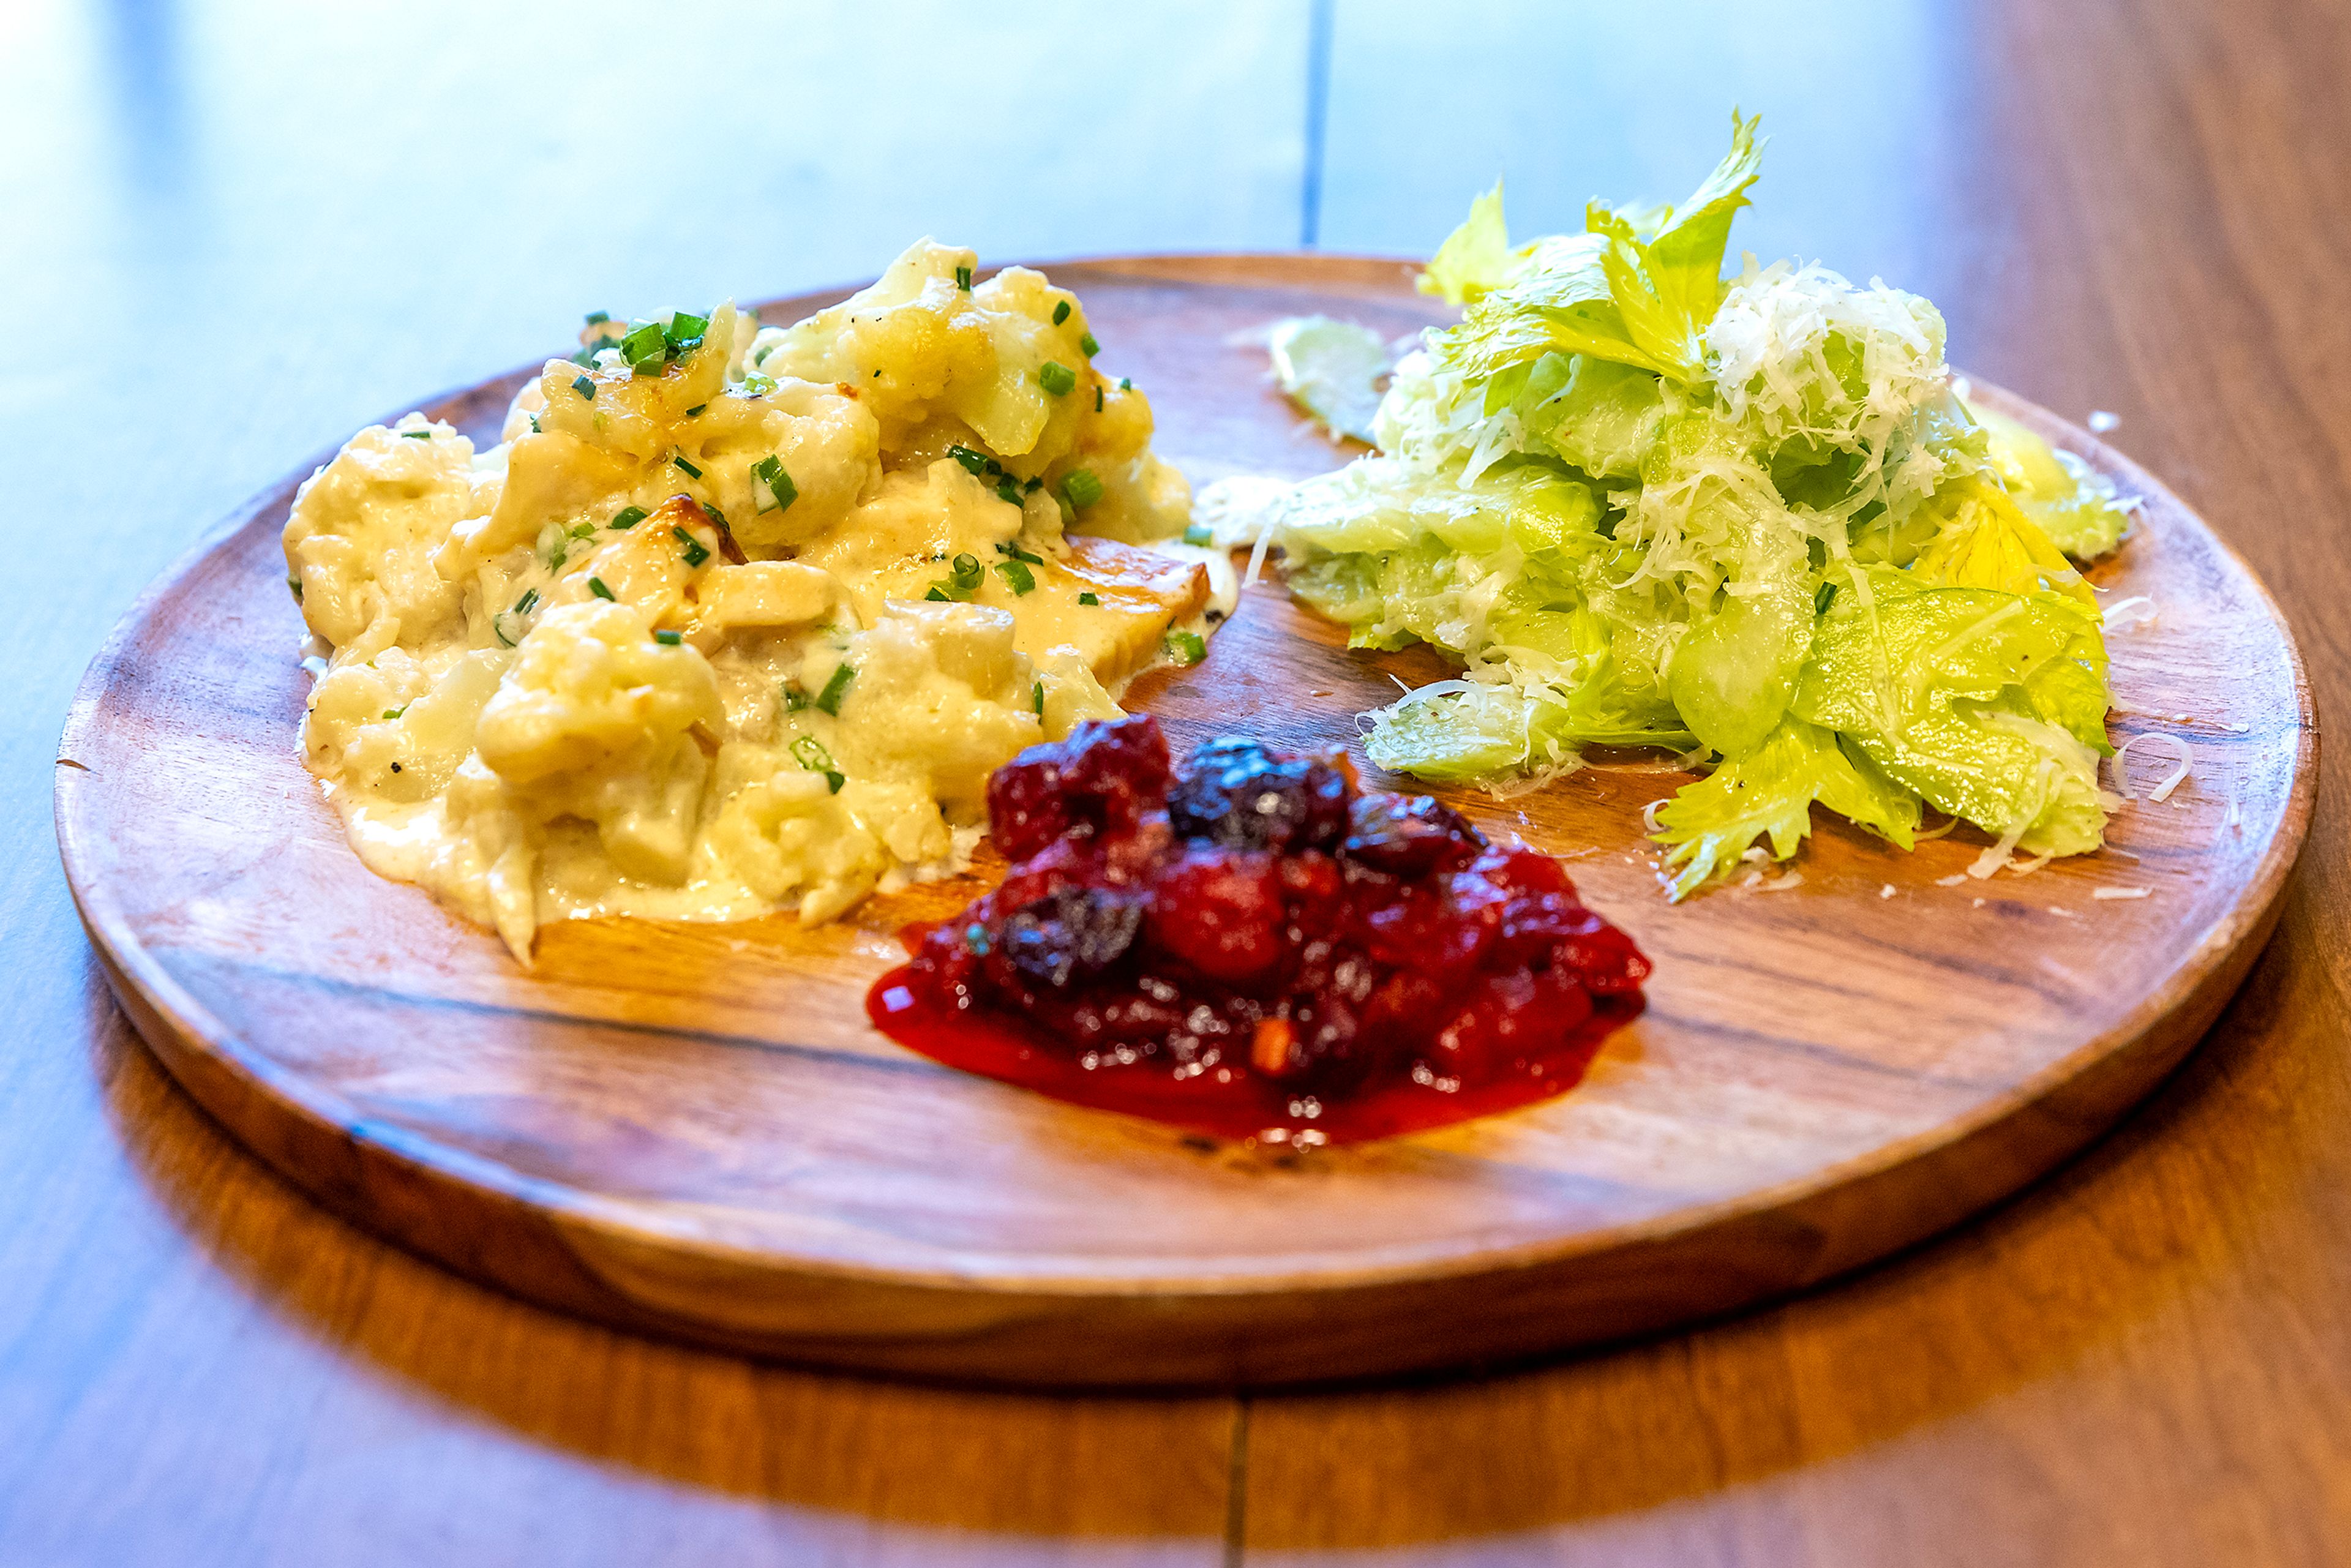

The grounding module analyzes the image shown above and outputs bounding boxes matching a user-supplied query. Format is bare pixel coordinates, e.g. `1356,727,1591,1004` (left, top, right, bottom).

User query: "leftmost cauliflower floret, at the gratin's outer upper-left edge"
285,414,498,658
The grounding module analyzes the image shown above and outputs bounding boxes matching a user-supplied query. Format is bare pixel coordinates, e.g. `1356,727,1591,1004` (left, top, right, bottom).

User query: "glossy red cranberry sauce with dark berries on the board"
865,717,1648,1145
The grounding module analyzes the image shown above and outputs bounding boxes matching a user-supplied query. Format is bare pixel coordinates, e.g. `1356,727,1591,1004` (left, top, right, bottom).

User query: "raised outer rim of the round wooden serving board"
56,252,2318,1387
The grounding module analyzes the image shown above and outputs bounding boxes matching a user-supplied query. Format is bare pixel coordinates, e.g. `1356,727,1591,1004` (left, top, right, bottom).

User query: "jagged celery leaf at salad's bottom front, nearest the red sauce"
1655,717,1918,901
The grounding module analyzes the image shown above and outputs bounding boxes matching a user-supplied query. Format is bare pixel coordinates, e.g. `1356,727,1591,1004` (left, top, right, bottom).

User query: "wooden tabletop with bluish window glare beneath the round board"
0,0,2351,1568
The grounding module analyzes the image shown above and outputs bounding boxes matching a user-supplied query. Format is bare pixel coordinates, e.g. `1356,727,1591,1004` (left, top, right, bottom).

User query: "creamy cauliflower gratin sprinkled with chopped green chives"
285,240,1232,961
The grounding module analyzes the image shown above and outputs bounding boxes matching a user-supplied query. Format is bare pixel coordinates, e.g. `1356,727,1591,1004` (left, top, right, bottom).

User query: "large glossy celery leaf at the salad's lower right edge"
1791,569,2107,853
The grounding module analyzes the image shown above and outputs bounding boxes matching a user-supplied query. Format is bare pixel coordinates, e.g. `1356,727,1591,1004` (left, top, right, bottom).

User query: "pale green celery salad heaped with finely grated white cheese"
1201,115,2135,898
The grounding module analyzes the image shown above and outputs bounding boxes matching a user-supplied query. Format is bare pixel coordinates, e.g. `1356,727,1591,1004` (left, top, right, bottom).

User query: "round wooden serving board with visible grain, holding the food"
56,257,2318,1385
